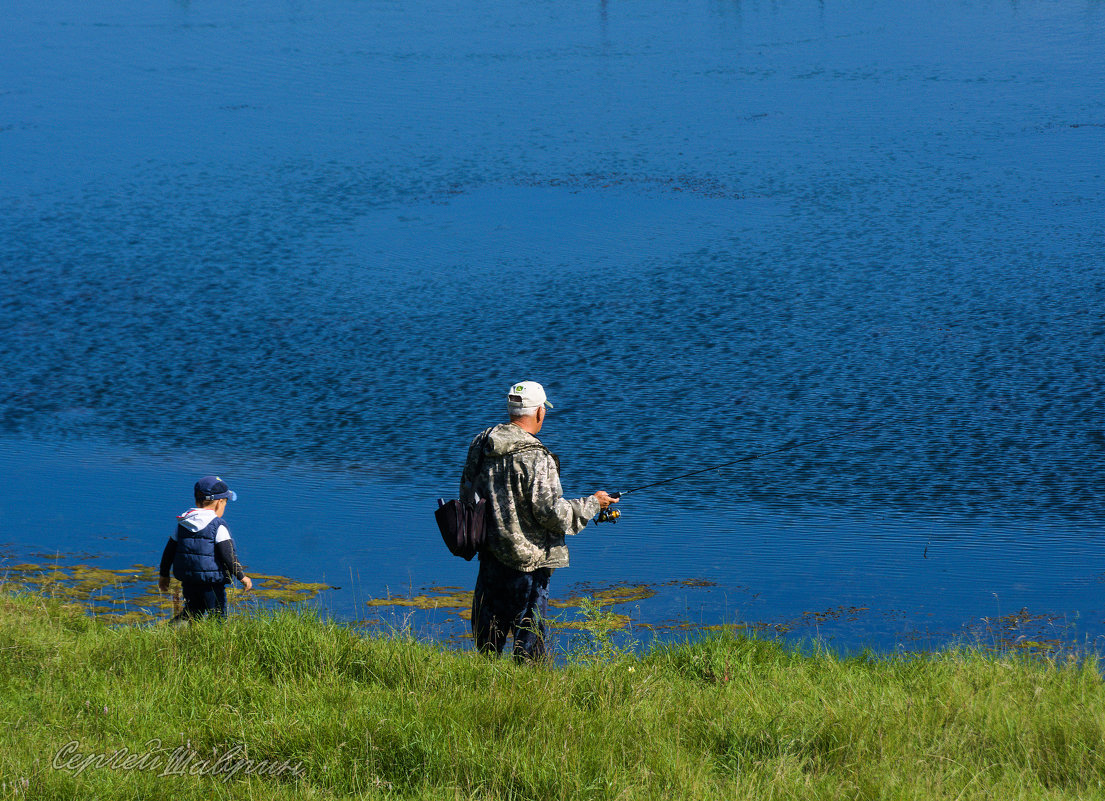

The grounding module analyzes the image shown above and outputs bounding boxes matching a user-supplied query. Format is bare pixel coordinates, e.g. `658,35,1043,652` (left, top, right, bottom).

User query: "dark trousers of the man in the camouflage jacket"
472,554,553,662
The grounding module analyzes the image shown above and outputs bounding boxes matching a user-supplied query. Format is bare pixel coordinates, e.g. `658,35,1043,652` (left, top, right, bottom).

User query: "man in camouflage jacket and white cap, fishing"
461,381,618,662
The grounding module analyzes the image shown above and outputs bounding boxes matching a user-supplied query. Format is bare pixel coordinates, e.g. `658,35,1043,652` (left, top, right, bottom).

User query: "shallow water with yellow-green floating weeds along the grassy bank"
0,536,1087,657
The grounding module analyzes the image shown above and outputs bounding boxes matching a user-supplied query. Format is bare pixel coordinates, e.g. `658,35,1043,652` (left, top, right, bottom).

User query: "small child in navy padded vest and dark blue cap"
157,475,253,618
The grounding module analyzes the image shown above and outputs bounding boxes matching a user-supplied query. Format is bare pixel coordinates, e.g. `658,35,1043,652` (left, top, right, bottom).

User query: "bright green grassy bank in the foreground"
0,593,1105,801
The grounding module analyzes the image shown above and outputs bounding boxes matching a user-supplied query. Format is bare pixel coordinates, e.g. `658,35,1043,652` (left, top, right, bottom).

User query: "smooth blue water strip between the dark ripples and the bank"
0,438,1105,654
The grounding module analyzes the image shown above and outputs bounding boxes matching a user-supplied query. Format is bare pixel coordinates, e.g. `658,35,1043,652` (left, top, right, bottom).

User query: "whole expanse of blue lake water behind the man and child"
0,0,1105,651
